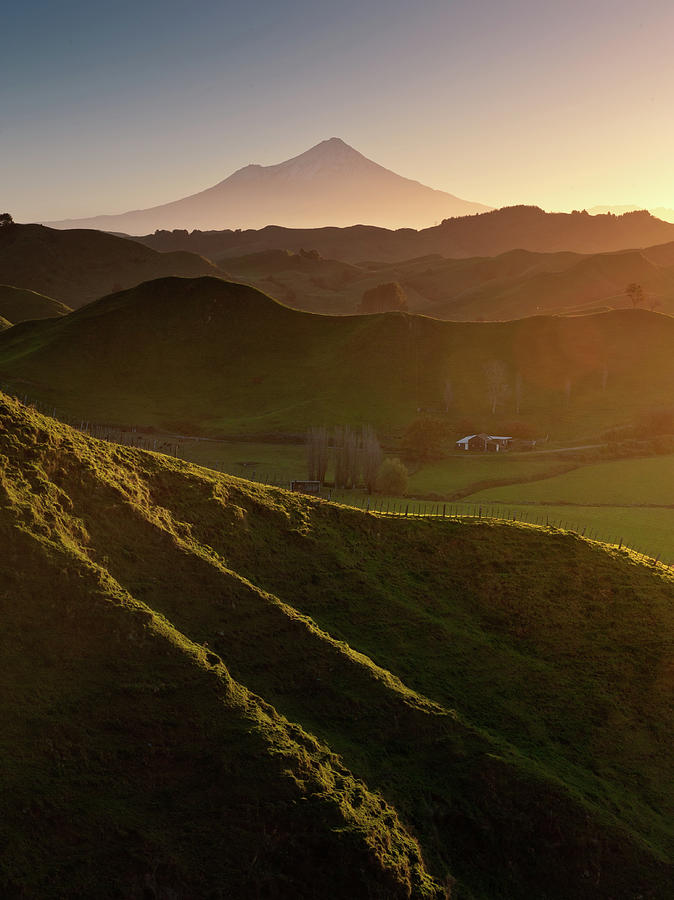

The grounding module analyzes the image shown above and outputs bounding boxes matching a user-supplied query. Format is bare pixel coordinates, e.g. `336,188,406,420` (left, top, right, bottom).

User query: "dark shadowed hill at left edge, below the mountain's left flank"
0,224,224,308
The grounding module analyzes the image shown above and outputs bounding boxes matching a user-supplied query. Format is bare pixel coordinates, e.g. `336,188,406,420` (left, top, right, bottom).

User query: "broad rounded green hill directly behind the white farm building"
0,278,674,440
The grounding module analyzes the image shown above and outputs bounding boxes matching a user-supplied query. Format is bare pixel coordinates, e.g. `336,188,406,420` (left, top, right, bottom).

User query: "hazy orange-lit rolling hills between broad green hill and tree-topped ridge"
223,247,674,321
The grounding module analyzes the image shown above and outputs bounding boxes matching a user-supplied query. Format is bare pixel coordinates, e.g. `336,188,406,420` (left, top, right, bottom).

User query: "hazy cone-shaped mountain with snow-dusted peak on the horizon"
50,137,489,235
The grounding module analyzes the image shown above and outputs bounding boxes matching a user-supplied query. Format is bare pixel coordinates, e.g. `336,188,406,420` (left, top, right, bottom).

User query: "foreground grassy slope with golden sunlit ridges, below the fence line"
0,397,674,900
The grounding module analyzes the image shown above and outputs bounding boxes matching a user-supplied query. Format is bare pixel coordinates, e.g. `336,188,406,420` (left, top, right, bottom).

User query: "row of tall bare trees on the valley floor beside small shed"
306,425,383,492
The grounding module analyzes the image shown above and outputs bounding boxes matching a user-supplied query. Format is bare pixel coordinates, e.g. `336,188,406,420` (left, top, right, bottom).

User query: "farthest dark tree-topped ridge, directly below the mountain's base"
138,206,674,263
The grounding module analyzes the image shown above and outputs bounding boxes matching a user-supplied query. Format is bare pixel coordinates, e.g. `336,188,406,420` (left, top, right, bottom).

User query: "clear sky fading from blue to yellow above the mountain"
0,0,674,221
